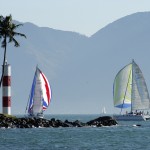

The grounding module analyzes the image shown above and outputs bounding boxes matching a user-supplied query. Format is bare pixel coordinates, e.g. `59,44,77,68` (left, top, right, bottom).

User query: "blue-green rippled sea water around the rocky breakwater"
0,114,150,150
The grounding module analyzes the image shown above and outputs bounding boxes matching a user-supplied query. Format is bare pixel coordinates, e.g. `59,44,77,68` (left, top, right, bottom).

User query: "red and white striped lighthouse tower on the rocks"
2,62,11,115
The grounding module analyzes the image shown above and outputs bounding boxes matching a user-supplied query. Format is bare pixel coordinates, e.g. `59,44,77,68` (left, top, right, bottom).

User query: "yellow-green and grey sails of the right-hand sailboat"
113,61,150,111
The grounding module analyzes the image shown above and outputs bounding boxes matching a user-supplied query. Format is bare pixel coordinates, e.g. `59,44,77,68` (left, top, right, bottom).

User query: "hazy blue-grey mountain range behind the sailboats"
0,12,150,114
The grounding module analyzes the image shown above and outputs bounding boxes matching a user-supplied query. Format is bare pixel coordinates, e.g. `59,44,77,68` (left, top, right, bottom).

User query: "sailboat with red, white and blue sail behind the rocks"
26,67,51,118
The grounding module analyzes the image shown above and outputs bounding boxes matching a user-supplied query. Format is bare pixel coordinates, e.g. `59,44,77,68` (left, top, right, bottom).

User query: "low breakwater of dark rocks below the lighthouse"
0,114,117,128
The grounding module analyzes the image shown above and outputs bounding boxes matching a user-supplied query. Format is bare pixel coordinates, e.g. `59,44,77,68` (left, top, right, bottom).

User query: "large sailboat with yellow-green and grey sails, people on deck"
113,60,150,121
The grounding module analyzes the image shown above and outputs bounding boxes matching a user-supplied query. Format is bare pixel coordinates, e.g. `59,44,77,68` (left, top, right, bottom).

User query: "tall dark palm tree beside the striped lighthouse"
0,15,26,87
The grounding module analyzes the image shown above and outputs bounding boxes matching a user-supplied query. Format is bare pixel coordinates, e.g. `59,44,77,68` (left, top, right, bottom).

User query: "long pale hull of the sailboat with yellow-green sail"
113,114,150,121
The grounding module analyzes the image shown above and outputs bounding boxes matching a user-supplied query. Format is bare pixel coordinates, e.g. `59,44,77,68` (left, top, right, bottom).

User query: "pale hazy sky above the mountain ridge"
0,0,150,36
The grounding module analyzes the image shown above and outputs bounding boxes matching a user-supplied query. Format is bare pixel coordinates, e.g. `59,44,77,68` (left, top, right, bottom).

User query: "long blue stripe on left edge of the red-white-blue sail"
28,74,36,113
